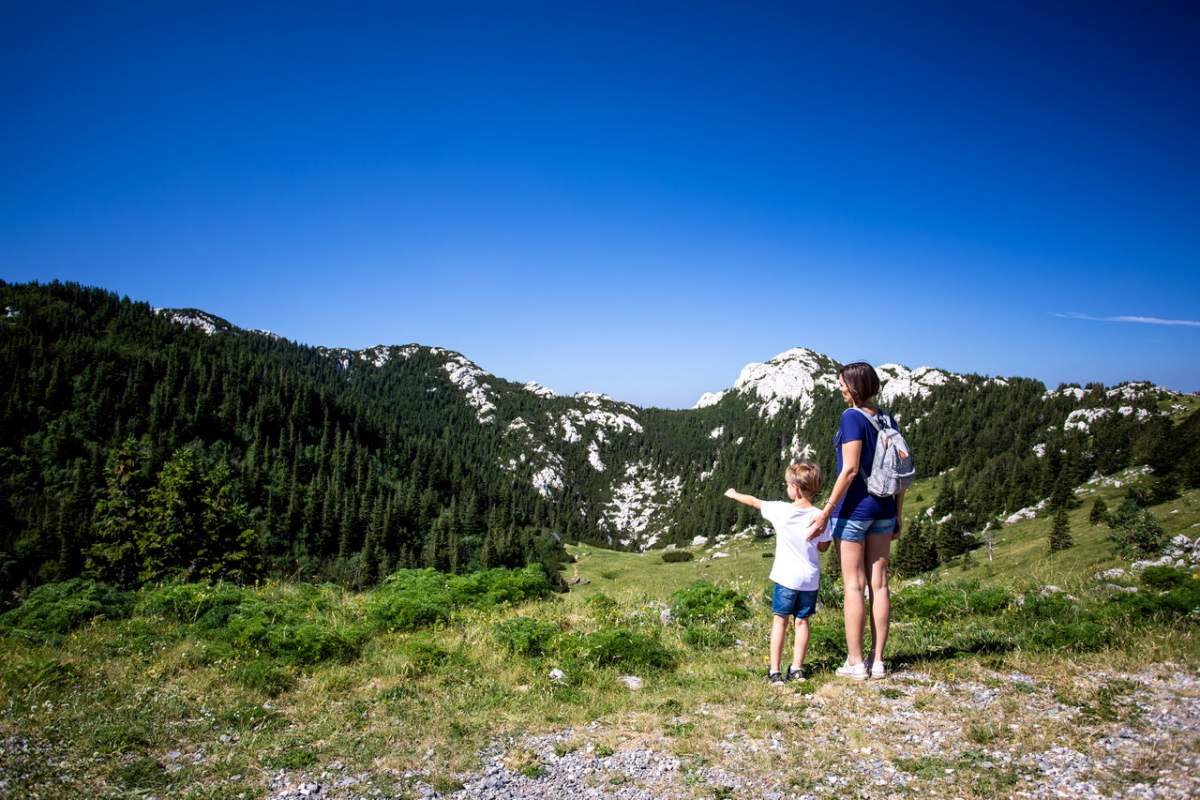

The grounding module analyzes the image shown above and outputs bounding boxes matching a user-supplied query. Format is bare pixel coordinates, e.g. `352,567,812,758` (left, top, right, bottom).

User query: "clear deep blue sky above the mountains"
0,2,1200,407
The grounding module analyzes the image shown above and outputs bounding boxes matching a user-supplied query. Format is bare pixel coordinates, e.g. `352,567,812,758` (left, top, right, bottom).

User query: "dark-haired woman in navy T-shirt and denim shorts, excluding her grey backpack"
810,361,904,680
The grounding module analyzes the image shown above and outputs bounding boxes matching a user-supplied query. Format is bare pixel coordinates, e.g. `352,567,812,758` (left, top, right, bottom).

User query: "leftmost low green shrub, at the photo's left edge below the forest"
0,578,133,634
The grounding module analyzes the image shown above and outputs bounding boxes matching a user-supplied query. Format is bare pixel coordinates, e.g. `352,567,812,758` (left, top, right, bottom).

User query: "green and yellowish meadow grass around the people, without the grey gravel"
0,474,1200,798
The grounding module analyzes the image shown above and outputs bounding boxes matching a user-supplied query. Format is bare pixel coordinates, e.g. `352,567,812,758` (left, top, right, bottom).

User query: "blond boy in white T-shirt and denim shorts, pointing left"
725,461,832,685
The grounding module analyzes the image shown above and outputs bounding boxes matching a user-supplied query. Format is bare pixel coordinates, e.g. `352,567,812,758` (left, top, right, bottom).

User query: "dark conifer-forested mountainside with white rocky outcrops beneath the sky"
0,283,1200,588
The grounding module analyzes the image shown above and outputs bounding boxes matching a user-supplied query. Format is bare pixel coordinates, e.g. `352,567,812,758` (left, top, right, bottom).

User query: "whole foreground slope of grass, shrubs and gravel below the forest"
0,474,1200,798
